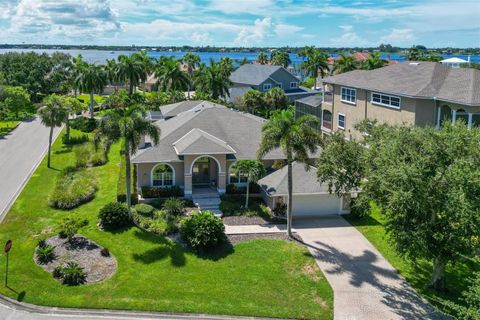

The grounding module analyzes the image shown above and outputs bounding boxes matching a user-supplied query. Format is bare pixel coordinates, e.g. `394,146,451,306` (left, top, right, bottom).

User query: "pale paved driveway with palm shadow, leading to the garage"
294,217,444,320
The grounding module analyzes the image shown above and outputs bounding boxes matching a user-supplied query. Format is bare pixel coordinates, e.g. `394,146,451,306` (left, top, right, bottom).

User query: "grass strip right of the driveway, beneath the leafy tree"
345,209,480,312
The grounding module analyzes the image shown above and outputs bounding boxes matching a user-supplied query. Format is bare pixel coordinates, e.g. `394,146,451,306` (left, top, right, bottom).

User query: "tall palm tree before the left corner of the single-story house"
95,97,160,214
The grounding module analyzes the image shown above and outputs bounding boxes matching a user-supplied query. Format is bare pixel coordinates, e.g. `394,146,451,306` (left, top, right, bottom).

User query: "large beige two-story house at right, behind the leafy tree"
296,61,480,137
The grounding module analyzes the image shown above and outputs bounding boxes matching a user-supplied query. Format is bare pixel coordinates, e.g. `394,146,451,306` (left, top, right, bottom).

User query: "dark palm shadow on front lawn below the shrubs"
132,230,186,267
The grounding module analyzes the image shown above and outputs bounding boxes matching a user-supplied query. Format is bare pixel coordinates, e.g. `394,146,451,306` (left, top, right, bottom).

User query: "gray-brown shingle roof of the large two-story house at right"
323,61,480,106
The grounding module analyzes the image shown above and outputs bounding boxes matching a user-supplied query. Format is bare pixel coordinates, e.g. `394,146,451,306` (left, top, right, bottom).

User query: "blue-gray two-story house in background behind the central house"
229,64,318,102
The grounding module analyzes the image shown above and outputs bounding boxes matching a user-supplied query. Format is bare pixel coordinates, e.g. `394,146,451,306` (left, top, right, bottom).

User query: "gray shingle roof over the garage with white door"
258,161,328,196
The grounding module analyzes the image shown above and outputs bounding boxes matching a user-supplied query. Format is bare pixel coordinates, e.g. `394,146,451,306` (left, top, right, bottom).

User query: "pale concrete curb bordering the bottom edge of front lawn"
0,294,280,320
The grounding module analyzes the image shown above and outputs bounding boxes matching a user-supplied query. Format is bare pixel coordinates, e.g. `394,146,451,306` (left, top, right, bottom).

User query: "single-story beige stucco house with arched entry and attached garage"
132,101,347,216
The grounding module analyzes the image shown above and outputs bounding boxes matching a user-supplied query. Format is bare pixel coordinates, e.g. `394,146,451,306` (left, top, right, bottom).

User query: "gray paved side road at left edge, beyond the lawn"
0,118,60,223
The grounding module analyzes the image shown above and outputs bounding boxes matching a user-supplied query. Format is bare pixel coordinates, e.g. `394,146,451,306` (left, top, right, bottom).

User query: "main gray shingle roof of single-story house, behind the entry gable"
132,101,285,163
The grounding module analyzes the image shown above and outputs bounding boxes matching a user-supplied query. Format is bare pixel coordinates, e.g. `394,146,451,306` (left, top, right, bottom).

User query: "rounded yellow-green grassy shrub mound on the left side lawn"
50,167,97,210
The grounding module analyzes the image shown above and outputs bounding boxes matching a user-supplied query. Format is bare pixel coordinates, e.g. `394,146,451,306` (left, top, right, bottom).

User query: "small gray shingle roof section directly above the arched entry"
173,128,236,155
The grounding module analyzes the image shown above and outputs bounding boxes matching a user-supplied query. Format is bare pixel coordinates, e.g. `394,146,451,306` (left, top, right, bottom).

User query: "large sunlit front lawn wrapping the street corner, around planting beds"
0,129,333,319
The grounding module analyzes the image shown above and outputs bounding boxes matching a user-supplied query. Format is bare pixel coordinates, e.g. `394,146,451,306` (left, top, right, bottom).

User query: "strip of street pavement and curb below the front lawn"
0,295,276,320
